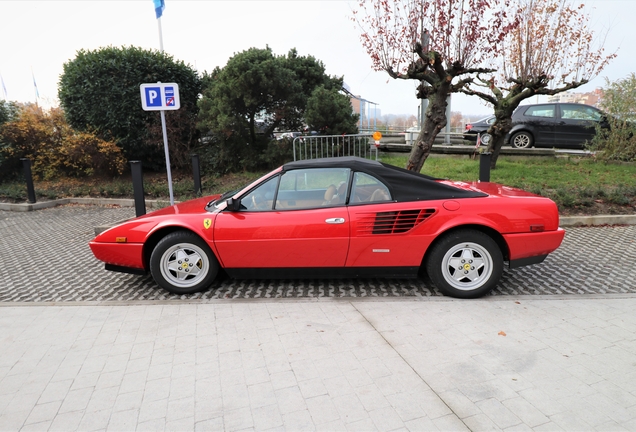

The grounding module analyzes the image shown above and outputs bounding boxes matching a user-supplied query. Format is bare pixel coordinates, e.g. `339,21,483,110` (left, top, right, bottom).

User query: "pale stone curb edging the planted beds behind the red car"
0,198,636,229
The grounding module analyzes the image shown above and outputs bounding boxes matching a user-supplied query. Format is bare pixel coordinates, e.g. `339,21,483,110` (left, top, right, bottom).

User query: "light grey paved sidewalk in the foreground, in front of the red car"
0,294,636,431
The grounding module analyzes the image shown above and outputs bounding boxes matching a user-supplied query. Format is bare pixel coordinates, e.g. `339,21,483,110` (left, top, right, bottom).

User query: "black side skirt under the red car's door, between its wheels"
224,267,420,279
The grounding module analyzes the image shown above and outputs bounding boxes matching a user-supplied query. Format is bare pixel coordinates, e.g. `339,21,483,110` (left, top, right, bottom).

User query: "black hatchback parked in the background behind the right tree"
506,103,609,149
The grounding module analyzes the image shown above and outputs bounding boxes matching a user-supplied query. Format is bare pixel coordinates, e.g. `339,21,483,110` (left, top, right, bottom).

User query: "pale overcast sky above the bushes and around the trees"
0,0,636,114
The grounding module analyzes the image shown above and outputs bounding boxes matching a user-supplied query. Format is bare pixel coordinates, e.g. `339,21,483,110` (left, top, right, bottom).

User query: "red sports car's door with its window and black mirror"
214,168,350,268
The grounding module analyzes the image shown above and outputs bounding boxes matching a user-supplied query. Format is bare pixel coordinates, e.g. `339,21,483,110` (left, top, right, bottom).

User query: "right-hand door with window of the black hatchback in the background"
555,104,602,148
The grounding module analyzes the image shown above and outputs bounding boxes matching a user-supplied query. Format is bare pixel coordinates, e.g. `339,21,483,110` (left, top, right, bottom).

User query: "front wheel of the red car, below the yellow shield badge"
150,231,220,295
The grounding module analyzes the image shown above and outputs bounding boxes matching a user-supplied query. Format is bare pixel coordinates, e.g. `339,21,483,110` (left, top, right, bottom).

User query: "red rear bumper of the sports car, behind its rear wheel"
503,228,565,267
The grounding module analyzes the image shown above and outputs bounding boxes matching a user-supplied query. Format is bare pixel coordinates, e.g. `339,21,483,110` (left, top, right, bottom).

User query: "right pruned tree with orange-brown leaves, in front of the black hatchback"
460,0,616,168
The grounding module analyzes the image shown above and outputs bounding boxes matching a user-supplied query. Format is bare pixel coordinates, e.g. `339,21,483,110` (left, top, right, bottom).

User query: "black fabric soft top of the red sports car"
283,156,488,201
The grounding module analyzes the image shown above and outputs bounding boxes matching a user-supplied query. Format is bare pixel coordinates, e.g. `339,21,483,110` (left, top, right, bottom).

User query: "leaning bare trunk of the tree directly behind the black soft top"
406,85,449,172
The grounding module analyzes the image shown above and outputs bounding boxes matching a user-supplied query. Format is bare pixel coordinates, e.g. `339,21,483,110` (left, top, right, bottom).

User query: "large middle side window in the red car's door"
275,168,351,210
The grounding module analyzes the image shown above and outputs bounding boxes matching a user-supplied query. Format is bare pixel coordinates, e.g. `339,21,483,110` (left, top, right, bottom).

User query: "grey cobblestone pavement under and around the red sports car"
0,205,636,302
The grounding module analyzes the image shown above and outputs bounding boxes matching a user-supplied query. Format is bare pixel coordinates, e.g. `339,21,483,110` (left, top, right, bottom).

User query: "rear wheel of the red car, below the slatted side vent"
426,229,503,298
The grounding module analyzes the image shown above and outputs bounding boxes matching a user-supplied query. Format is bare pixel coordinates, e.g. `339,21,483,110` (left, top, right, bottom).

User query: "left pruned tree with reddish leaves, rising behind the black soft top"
354,0,518,171
